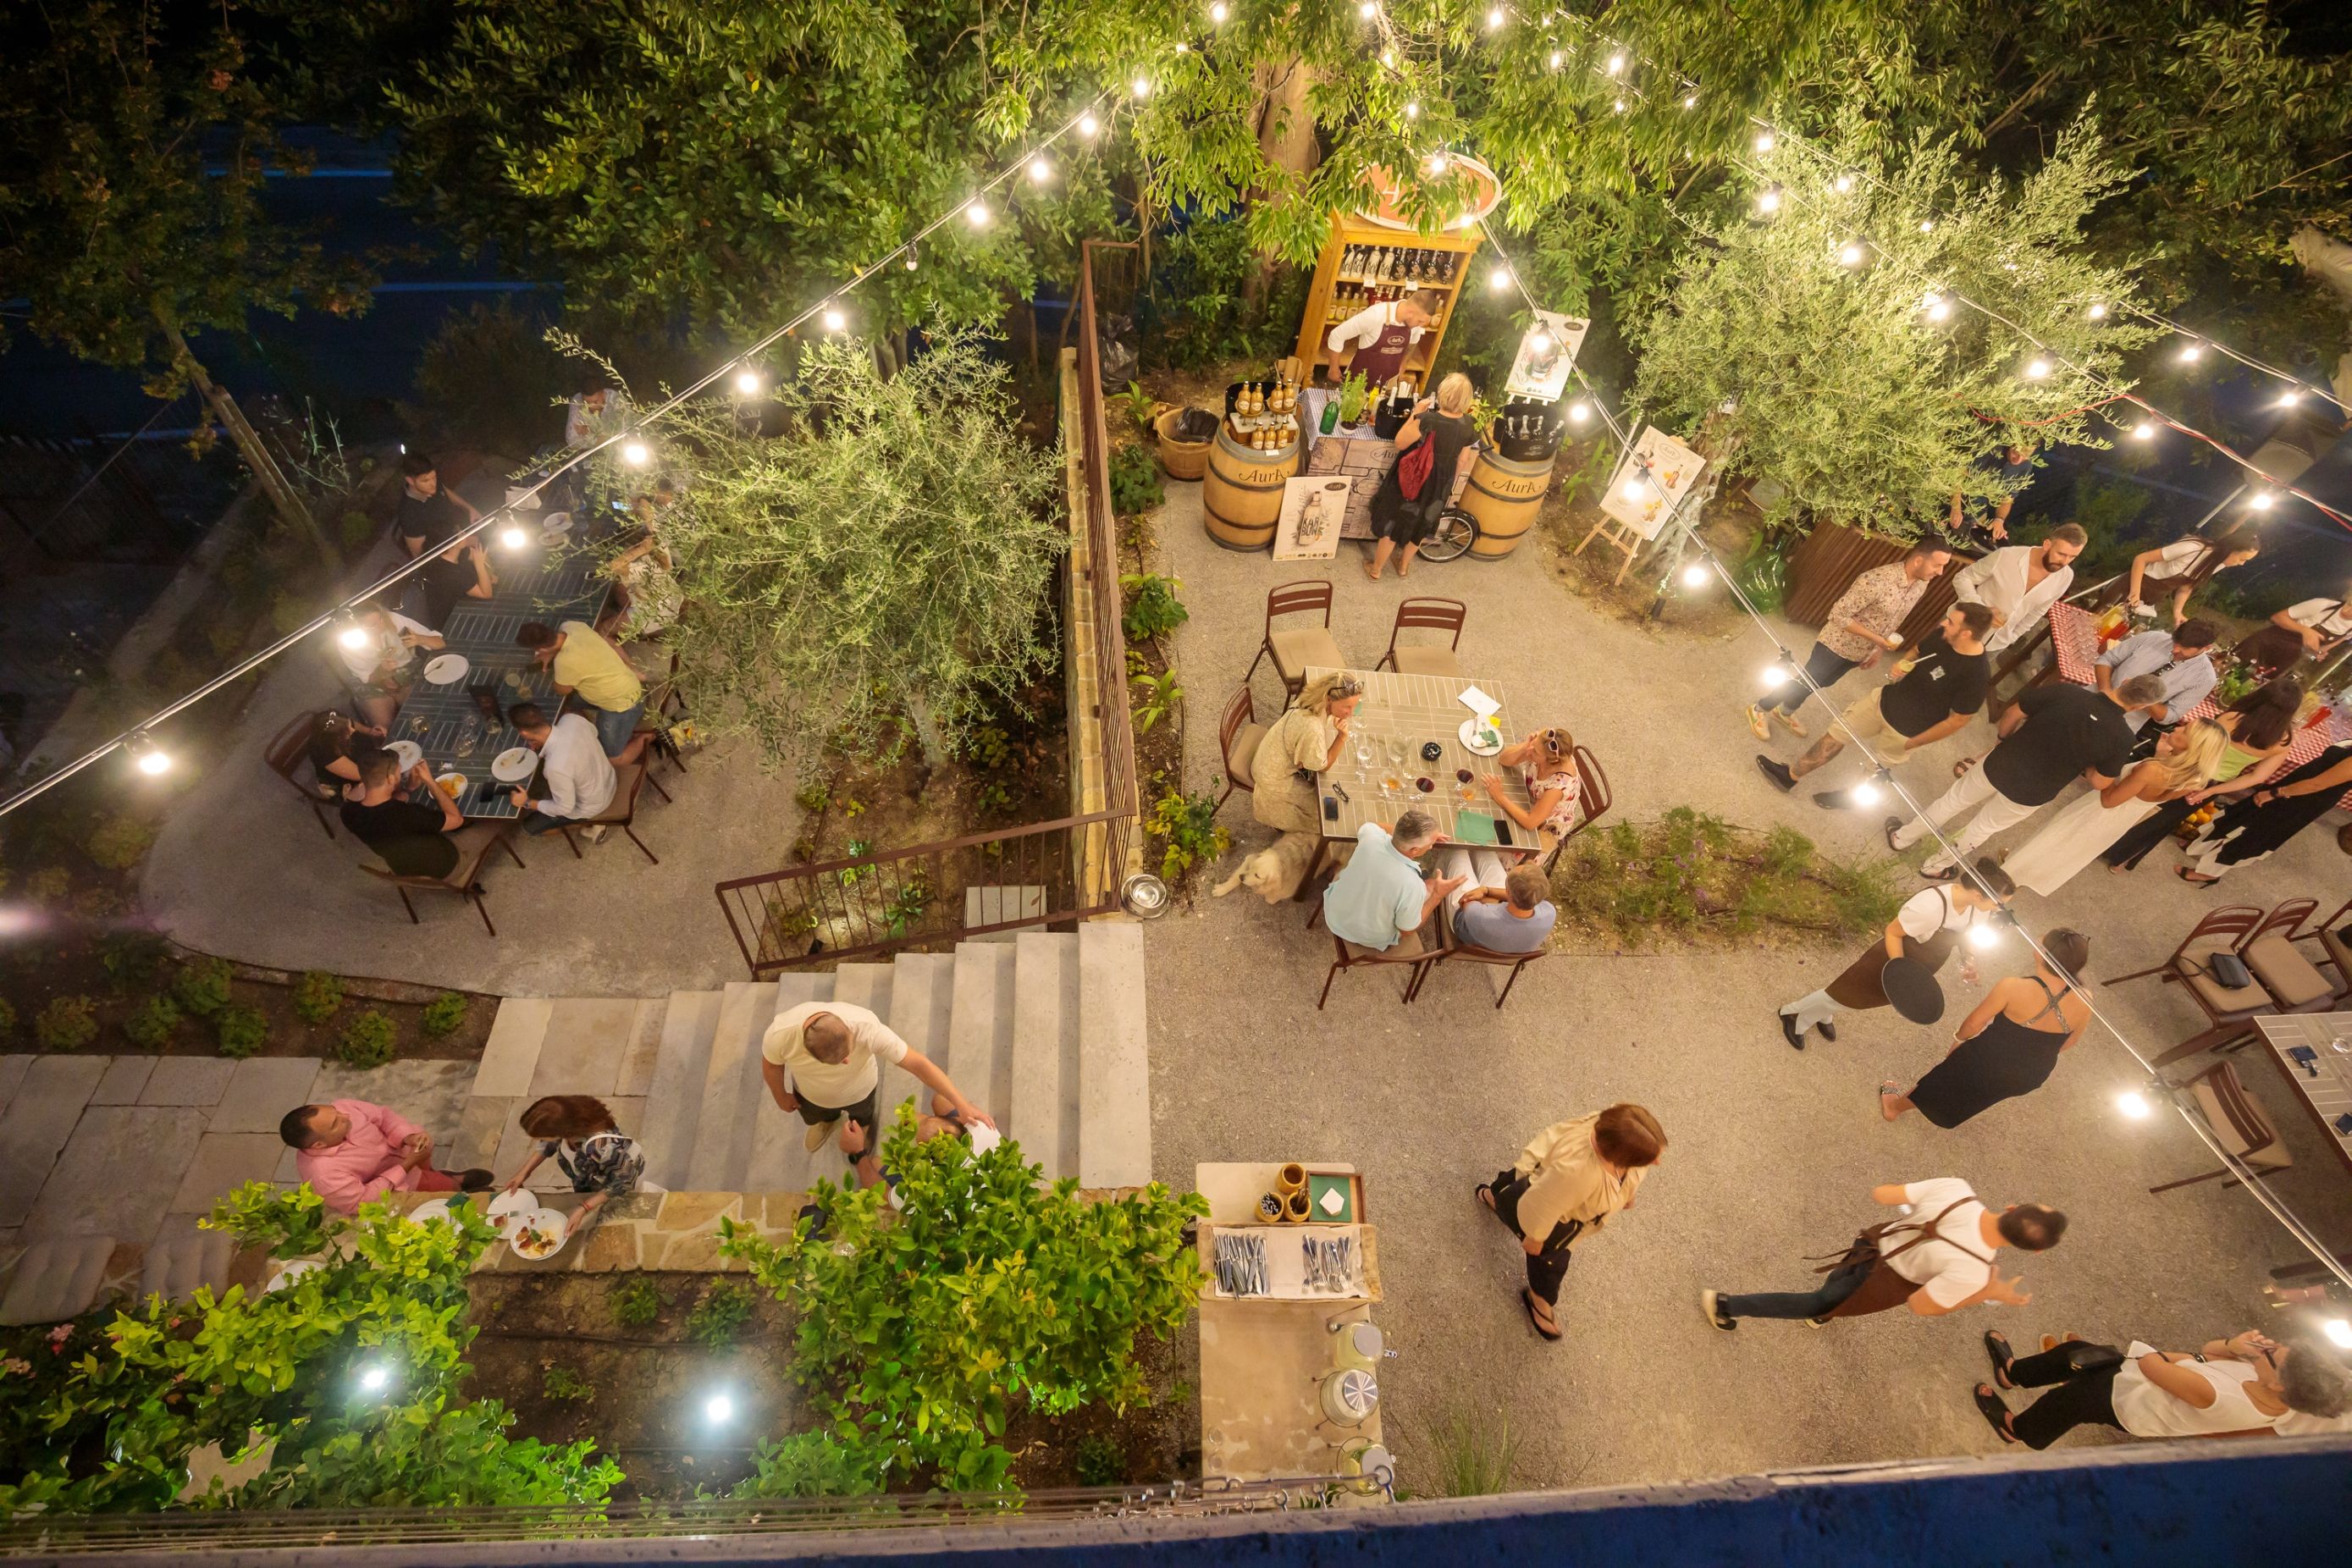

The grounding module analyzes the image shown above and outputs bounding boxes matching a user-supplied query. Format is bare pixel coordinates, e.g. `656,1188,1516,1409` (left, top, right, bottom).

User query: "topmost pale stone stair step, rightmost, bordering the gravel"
1077,919,1152,1187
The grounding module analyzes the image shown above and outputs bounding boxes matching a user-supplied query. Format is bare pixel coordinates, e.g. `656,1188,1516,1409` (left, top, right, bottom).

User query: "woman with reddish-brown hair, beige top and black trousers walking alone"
1472,1102,1665,1340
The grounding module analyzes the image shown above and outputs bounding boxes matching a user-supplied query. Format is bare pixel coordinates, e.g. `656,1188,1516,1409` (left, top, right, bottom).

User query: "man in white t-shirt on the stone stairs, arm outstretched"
759,1002,995,1184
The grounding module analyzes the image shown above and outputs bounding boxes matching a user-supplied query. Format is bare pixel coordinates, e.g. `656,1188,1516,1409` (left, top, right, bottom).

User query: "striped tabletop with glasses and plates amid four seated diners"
1308,668,1533,848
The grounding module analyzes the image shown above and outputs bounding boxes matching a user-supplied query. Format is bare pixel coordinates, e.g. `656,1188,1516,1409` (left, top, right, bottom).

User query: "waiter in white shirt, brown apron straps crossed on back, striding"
1698,1175,2065,1328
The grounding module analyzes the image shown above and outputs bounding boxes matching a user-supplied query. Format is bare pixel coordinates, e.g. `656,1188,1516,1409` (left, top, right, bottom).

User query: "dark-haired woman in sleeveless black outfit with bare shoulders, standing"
1880,929,2091,1126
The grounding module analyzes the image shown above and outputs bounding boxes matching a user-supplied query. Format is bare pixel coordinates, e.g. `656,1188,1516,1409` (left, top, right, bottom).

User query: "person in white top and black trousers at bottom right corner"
1971,1328,2352,1450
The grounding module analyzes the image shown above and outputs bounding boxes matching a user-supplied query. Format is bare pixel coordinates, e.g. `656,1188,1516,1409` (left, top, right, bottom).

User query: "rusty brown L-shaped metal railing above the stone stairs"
715,240,1139,980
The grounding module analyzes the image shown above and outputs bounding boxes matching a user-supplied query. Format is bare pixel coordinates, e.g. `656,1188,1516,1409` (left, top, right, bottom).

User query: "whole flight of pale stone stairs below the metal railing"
640,921,1152,1192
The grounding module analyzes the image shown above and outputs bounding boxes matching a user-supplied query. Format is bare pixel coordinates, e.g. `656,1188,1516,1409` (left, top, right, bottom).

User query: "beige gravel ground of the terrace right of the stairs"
1148,484,2352,1486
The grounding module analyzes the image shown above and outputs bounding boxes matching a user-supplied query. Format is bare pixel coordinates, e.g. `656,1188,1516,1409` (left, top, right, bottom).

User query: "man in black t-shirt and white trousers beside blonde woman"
1886,675,2164,879
